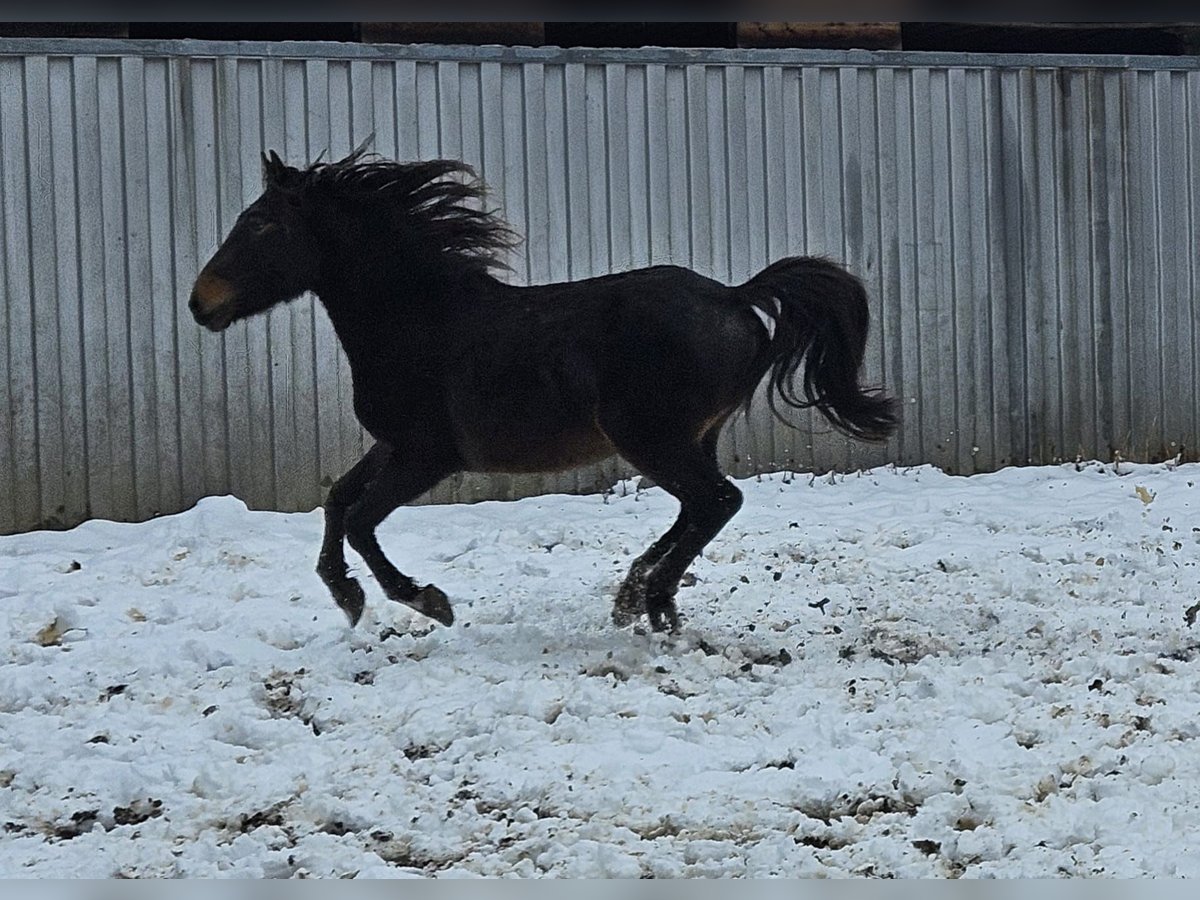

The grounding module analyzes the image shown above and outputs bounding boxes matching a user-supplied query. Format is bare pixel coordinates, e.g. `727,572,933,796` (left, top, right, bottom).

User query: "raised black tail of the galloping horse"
738,257,900,440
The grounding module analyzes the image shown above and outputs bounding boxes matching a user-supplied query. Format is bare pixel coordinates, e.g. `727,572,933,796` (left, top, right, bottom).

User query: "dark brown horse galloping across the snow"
190,151,896,630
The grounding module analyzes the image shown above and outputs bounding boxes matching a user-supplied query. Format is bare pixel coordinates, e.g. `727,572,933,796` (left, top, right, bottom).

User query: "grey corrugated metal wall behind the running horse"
0,41,1200,532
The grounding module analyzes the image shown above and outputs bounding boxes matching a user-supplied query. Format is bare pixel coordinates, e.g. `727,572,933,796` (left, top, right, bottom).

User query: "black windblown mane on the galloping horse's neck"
300,148,521,272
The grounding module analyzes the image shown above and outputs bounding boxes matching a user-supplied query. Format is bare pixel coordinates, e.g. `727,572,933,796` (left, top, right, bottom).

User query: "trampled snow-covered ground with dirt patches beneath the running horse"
0,463,1200,877
